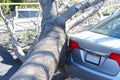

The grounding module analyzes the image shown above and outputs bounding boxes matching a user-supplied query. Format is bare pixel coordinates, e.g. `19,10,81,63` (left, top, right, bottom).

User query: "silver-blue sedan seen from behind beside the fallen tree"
66,12,120,80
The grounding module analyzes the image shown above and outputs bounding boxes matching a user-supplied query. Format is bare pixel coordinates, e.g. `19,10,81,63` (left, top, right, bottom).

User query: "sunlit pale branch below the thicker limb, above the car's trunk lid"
66,2,103,32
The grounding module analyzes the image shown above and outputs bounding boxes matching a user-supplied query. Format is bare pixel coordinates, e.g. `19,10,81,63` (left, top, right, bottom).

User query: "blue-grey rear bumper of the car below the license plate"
66,56,120,80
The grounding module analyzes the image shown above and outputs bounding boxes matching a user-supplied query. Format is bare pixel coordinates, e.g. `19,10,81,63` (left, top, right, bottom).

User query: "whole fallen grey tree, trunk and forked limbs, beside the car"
3,0,104,80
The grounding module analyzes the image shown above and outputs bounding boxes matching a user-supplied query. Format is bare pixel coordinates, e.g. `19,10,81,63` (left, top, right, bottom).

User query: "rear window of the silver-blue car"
91,18,120,38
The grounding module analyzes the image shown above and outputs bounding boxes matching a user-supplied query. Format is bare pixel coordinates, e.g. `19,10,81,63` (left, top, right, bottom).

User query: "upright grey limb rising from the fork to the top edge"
39,0,57,26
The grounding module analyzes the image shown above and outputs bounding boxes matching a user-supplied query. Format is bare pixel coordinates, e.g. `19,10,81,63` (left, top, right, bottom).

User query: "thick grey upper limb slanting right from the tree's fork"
55,0,104,24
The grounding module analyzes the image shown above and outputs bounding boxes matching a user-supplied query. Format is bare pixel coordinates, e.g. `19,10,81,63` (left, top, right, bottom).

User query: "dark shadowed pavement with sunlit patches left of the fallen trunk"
0,46,22,80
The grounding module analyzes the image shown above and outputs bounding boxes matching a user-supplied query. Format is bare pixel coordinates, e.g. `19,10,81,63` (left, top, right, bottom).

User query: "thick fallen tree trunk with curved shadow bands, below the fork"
10,24,66,80
